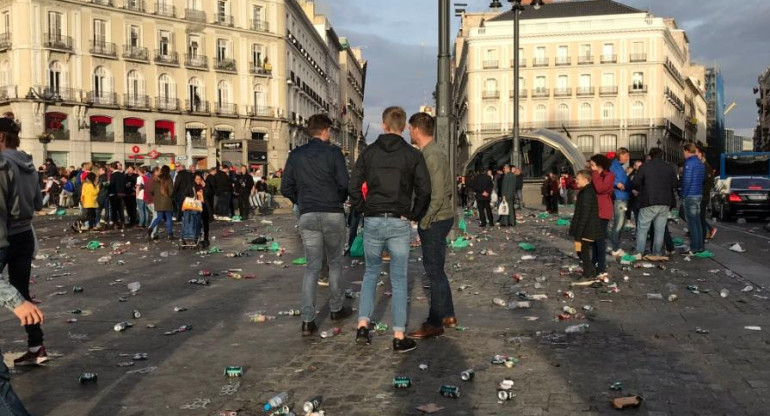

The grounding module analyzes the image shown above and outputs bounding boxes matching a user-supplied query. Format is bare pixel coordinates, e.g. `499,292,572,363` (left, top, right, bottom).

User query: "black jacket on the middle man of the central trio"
350,134,431,221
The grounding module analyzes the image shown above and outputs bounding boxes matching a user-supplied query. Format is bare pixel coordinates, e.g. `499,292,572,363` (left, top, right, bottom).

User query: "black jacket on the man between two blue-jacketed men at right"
634,159,677,208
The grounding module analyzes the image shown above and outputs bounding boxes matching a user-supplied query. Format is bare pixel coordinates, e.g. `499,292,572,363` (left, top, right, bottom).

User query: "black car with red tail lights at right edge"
711,176,770,221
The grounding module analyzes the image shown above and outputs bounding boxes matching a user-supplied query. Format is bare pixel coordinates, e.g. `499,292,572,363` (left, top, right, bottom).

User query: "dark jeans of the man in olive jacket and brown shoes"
417,218,455,327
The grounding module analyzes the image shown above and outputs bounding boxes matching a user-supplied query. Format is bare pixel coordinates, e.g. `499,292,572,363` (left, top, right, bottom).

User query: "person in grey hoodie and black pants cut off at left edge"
0,118,47,366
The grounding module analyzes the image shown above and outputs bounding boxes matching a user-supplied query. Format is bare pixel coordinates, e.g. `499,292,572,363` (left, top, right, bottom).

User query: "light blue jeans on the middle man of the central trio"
358,217,411,332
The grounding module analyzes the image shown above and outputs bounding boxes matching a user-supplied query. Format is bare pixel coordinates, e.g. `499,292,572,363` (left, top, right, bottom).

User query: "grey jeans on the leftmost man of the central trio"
299,212,345,322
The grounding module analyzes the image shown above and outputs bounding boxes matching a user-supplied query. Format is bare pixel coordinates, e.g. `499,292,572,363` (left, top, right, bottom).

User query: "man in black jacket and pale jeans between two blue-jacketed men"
634,147,677,261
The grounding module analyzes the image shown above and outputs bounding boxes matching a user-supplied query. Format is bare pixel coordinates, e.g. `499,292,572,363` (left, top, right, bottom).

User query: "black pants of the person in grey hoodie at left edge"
7,230,43,347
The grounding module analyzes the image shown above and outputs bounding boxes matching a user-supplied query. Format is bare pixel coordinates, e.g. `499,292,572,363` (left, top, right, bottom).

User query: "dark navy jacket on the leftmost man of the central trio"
281,138,350,215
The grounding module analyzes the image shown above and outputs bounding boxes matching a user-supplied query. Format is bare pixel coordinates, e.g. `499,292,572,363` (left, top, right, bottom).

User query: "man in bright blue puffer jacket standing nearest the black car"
680,143,706,253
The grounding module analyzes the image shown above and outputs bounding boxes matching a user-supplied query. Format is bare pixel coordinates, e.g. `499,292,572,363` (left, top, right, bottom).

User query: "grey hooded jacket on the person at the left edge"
3,149,43,235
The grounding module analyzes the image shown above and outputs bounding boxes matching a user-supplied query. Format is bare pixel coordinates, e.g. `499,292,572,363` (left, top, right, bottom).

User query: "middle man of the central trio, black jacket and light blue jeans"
350,107,431,352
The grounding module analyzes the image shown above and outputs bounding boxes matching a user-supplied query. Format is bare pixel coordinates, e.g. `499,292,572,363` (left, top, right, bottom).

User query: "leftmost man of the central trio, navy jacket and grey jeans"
281,114,353,336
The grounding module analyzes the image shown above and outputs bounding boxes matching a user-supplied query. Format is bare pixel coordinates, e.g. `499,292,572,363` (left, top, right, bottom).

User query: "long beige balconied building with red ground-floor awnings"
0,0,366,172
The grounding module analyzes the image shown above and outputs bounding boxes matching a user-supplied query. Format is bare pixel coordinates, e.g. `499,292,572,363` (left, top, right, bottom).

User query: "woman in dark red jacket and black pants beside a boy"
589,155,615,277
